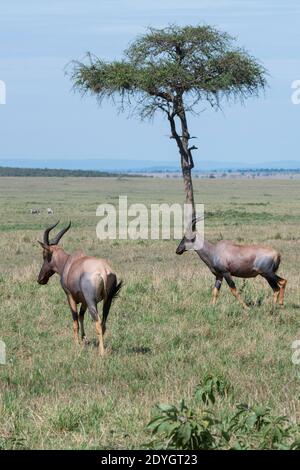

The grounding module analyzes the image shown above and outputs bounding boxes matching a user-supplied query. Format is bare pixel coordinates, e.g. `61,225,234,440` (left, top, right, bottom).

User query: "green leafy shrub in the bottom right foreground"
147,375,300,450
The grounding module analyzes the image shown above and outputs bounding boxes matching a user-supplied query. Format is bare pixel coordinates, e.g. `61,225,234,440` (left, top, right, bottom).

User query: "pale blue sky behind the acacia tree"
0,0,300,168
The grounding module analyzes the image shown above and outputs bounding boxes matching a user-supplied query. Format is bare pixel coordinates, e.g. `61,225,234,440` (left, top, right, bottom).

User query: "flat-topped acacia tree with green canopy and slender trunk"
71,25,266,222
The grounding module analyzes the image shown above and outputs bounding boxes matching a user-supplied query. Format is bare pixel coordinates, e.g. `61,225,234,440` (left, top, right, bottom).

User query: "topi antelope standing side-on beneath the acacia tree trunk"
176,218,287,308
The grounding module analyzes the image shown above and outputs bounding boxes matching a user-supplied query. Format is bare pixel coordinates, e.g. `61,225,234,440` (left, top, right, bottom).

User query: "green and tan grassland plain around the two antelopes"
0,178,300,449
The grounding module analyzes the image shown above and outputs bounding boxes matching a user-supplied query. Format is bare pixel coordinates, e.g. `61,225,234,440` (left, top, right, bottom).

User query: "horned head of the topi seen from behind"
37,221,71,284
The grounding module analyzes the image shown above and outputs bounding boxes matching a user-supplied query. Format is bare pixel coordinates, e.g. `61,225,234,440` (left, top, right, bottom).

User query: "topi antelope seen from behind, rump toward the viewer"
37,222,122,356
